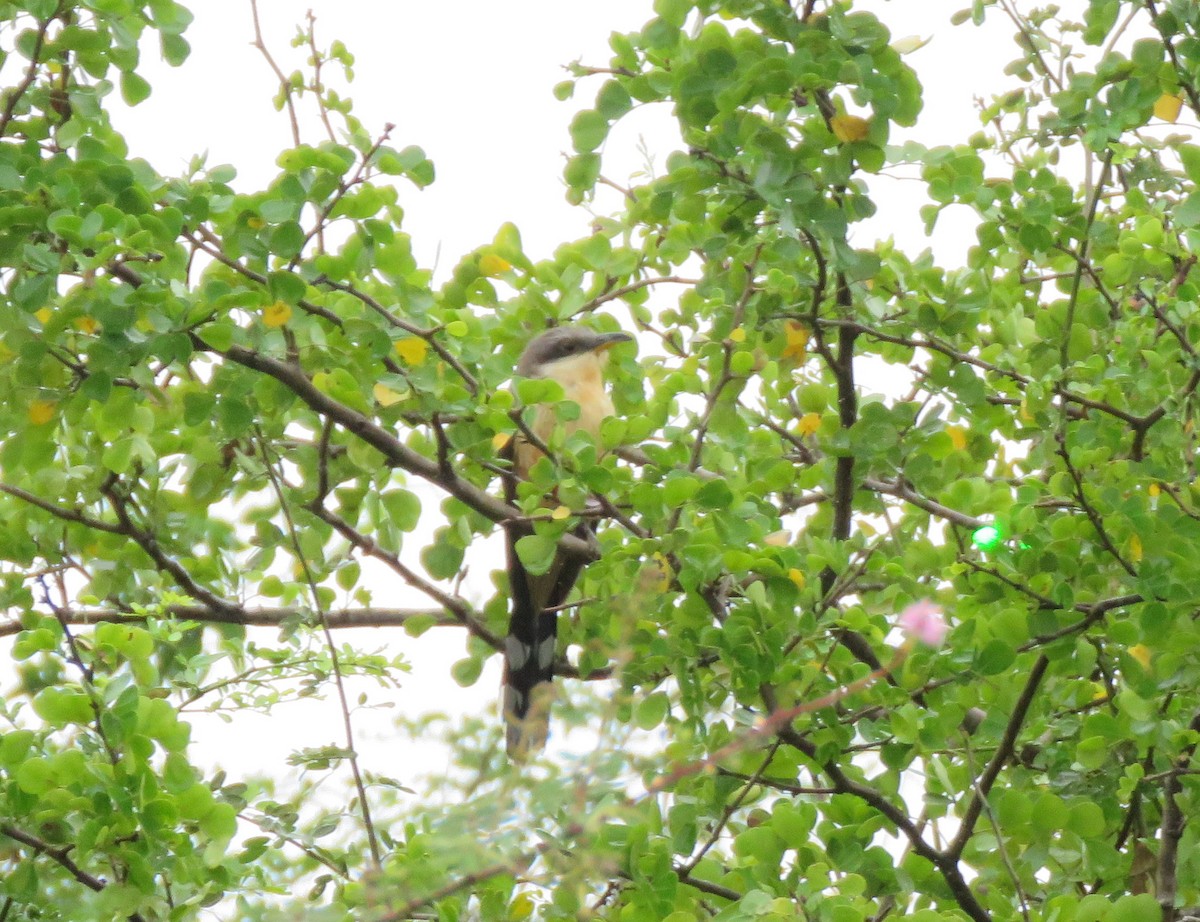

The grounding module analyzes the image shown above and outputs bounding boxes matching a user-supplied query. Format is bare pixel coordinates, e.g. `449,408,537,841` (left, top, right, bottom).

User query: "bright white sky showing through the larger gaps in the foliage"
9,0,1027,782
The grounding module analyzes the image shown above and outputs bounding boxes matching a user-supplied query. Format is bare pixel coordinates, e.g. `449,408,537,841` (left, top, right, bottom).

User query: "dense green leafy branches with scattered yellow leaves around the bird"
0,0,1200,922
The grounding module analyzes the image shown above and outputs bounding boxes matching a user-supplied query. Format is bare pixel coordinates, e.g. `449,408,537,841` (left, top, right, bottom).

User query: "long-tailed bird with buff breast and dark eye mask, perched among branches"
502,327,632,761
